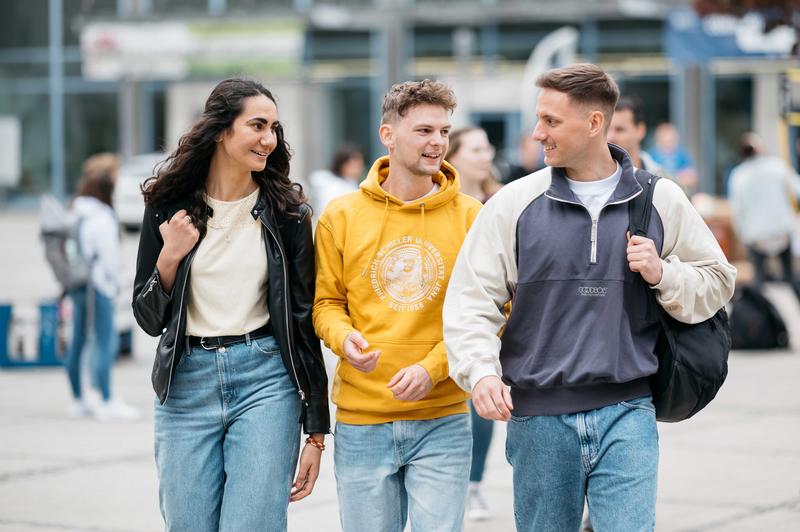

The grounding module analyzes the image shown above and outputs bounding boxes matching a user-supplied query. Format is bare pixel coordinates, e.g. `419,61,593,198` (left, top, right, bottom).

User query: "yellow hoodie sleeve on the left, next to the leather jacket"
313,216,355,357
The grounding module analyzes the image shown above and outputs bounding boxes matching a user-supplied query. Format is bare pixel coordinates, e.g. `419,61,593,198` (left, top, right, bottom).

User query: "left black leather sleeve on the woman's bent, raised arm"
132,205,172,336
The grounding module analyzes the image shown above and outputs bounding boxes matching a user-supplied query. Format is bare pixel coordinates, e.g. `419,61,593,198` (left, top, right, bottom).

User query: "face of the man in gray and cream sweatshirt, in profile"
533,89,606,168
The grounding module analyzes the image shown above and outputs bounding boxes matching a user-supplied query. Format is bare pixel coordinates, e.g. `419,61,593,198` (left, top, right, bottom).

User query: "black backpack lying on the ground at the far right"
731,286,789,349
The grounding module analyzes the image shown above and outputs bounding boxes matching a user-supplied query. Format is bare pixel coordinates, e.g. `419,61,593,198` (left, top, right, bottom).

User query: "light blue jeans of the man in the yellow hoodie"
334,414,472,532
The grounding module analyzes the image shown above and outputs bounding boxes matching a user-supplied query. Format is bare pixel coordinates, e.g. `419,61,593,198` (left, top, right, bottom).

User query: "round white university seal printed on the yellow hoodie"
370,235,445,312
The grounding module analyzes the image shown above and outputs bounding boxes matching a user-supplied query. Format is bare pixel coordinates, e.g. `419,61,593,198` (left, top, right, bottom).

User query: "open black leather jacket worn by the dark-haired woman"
133,190,330,434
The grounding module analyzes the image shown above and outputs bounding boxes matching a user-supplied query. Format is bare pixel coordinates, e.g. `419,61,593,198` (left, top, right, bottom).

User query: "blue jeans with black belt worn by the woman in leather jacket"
155,336,301,532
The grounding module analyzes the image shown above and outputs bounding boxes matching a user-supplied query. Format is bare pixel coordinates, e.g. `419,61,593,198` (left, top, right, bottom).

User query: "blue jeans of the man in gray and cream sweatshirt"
506,396,658,532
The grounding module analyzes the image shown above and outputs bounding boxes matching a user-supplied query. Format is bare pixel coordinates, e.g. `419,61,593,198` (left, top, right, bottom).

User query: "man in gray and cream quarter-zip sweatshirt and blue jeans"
444,64,736,532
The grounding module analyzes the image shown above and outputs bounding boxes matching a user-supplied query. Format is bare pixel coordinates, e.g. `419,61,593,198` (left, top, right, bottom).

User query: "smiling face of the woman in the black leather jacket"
214,94,280,172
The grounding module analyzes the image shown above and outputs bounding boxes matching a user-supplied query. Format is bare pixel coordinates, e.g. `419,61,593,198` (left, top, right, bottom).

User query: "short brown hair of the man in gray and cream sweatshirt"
536,63,619,125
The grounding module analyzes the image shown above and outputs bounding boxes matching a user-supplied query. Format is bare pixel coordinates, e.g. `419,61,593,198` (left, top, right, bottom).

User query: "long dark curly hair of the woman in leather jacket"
141,78,306,237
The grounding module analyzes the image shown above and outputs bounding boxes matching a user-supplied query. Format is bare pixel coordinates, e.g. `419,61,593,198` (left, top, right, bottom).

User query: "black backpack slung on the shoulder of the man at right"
628,169,731,422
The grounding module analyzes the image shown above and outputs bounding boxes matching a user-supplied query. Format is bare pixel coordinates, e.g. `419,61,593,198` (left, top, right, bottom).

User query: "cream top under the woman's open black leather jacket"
186,189,269,336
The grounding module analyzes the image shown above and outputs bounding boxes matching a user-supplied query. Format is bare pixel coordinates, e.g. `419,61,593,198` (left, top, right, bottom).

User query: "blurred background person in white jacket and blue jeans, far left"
65,153,138,421
